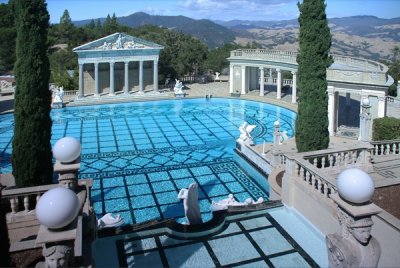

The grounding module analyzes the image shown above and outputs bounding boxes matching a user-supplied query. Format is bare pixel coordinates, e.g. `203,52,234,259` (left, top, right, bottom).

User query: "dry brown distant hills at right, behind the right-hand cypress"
215,16,400,60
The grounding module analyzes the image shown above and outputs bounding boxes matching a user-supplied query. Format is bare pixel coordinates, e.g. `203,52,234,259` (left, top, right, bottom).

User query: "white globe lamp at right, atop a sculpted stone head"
336,168,375,204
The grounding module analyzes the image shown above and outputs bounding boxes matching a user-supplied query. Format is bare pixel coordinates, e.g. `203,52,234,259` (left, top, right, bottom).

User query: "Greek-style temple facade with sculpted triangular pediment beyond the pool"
73,33,163,98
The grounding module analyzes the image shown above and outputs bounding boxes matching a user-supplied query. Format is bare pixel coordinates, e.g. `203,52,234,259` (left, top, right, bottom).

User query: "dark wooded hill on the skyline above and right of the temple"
74,12,236,48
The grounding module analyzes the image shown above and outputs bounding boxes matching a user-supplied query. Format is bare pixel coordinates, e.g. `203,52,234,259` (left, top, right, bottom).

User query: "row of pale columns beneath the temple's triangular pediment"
78,59,158,98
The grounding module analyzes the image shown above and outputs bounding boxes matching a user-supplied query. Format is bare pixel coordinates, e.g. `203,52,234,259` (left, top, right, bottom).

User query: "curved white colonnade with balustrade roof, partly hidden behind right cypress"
228,49,393,135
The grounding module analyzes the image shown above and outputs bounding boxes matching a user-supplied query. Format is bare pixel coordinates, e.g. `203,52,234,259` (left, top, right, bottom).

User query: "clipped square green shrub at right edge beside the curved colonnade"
372,117,400,141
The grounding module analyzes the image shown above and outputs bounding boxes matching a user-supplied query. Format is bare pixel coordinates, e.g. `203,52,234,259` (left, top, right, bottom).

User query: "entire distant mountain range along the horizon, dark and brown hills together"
74,12,400,60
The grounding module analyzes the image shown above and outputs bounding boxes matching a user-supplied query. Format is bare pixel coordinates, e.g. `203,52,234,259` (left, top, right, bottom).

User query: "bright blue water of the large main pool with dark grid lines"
0,98,296,224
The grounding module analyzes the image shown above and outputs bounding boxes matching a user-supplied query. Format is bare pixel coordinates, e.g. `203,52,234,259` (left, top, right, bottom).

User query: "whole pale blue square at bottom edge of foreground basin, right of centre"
209,234,260,265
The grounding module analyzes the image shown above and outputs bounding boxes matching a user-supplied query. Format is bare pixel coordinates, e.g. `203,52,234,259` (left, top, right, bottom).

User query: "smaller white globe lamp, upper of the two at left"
53,137,81,163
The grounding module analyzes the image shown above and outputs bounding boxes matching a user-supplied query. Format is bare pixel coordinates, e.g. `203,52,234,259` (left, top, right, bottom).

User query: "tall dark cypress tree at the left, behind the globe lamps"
12,0,53,187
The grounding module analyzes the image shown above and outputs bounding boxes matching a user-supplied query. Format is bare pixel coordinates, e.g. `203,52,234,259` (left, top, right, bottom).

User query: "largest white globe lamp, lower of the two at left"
36,187,79,229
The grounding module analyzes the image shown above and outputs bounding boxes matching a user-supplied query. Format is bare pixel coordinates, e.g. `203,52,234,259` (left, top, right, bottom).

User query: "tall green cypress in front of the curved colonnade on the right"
296,0,333,152
